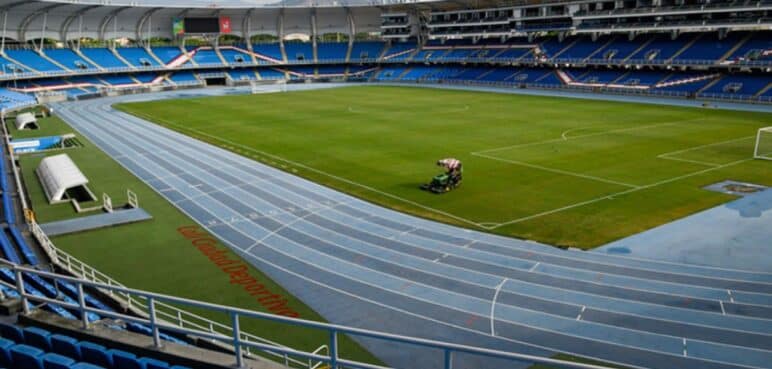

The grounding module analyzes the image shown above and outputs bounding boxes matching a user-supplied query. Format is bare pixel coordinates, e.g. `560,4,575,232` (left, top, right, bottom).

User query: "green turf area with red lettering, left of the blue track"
7,117,380,364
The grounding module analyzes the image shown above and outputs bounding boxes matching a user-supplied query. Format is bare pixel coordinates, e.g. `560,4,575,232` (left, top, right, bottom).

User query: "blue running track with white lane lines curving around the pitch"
55,85,772,369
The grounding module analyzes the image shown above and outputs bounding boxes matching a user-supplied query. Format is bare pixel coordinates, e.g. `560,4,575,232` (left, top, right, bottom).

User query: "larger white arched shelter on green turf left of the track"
35,154,88,203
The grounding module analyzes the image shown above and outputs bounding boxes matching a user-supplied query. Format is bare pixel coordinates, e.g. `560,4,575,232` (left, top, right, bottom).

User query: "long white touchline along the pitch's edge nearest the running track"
124,112,490,229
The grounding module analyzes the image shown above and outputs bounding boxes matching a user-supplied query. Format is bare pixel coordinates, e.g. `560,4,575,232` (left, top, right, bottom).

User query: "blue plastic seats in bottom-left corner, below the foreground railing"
0,324,188,369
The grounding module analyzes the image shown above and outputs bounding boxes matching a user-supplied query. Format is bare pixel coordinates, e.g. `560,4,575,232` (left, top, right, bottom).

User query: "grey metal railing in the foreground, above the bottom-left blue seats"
2,261,610,369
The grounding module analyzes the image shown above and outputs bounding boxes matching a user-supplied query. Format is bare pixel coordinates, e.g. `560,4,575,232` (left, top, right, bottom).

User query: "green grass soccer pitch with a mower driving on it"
118,87,772,248
